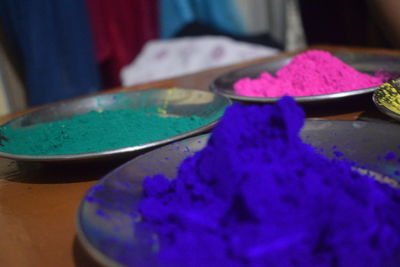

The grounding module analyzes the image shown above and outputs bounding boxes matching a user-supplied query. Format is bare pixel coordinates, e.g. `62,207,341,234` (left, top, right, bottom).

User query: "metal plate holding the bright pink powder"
210,53,400,104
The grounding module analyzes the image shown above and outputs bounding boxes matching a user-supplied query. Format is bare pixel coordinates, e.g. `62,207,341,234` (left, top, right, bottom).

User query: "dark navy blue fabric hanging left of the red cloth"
0,0,100,105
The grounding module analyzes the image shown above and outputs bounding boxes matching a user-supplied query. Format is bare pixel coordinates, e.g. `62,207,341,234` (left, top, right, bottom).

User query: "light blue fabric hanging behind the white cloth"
159,0,245,38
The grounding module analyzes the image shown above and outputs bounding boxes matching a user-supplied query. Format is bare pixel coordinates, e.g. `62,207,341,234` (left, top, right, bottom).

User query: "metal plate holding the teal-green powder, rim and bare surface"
0,88,231,162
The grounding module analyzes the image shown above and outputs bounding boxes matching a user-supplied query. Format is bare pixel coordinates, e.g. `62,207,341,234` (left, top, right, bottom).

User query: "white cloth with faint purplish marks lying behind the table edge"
120,36,279,86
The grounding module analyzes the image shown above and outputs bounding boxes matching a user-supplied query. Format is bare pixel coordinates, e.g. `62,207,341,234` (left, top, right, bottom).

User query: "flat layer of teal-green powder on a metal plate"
0,106,218,155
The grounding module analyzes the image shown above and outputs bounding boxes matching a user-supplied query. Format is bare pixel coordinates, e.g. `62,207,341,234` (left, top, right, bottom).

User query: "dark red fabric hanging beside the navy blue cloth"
86,0,158,88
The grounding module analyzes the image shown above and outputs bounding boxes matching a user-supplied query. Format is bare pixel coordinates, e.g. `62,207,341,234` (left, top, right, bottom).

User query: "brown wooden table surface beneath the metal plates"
0,46,400,266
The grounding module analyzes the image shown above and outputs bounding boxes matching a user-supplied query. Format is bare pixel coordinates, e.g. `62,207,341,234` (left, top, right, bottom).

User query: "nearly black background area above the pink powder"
299,0,392,48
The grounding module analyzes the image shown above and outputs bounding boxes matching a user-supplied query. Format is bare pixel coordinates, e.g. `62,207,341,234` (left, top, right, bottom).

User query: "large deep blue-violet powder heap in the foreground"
139,97,400,267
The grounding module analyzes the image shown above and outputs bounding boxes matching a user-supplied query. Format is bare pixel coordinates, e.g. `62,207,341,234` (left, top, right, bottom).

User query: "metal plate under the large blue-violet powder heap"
77,120,400,266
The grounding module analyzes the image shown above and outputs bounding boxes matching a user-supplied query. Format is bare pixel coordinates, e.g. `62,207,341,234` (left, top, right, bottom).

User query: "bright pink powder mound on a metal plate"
234,50,385,97
